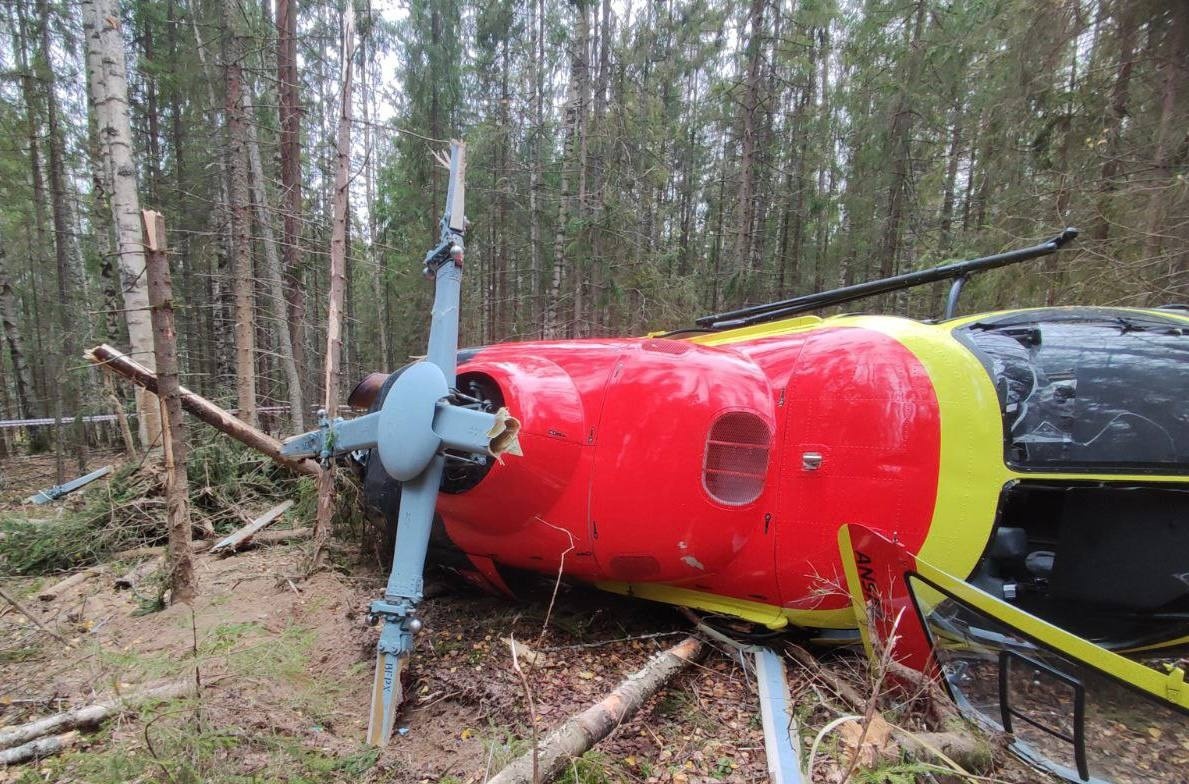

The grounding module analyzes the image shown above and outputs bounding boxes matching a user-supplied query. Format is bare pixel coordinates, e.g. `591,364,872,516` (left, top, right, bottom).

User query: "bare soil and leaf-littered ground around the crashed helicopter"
0,459,1169,784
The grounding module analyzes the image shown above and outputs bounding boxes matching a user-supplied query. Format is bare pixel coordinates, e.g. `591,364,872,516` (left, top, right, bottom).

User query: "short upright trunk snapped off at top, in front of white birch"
140,209,198,604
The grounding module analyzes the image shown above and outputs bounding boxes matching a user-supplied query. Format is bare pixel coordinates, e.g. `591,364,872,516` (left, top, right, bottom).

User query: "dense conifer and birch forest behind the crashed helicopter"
0,0,1189,451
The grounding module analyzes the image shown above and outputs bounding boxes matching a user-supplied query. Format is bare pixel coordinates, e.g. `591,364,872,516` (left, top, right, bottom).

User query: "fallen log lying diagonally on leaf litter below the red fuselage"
489,636,704,784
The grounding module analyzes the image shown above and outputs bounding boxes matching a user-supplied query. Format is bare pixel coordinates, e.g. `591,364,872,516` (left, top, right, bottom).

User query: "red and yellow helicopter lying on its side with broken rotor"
284,143,1189,742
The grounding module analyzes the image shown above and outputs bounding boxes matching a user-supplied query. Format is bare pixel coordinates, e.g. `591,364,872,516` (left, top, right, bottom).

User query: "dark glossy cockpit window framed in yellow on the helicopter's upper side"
958,308,1189,472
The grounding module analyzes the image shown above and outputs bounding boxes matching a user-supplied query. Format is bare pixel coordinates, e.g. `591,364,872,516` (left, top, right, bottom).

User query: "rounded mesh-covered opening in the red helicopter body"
703,412,772,506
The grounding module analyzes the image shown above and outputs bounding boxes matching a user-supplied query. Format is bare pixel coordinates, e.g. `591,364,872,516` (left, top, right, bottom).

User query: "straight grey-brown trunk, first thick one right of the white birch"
224,0,258,427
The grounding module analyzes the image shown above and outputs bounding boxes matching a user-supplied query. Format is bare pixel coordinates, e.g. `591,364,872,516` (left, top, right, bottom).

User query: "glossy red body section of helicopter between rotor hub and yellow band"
439,328,939,609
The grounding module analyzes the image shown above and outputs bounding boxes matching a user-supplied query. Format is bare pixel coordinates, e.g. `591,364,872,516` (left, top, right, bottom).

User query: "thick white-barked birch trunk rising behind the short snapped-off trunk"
82,0,161,449
